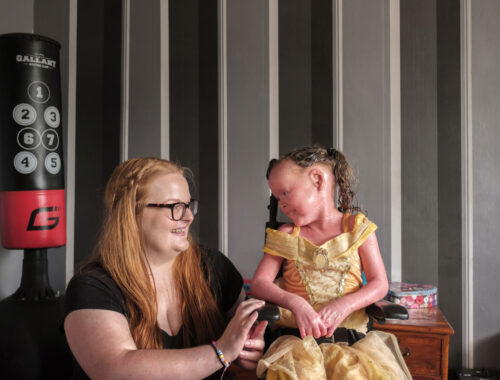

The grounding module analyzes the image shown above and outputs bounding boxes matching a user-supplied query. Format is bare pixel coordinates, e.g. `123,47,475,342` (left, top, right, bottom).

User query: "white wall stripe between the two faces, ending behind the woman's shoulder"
218,0,228,255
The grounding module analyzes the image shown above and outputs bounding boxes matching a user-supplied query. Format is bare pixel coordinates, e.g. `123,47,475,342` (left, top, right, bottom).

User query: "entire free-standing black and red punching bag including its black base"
0,34,71,380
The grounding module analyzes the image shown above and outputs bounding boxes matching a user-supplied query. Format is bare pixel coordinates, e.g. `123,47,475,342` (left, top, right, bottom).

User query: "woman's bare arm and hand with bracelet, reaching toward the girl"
64,299,264,380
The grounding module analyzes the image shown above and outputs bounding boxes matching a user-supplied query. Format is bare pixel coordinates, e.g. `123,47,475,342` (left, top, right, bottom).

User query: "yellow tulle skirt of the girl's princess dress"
257,331,411,380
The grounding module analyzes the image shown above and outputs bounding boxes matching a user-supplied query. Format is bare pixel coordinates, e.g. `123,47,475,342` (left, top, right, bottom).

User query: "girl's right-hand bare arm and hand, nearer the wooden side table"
319,233,389,336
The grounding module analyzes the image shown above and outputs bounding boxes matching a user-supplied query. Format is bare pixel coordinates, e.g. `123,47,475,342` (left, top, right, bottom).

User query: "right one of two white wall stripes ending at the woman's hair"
160,0,170,159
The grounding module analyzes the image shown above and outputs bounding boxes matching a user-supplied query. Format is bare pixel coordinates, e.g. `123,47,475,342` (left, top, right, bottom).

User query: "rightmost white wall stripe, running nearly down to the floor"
460,0,474,368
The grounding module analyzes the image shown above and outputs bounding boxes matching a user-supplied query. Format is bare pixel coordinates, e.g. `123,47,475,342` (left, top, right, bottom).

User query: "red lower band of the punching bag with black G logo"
0,189,66,249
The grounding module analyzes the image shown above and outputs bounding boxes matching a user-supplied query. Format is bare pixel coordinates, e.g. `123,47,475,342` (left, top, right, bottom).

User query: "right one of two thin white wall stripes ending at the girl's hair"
333,0,344,150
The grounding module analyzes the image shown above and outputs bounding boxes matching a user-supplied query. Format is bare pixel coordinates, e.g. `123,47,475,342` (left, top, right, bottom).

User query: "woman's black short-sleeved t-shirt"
64,247,243,380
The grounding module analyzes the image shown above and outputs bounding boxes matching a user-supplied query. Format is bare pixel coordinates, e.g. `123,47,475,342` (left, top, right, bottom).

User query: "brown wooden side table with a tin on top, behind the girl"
373,307,453,380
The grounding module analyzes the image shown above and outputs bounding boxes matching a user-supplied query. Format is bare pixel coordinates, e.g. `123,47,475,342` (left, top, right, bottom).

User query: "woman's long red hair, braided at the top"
85,158,224,349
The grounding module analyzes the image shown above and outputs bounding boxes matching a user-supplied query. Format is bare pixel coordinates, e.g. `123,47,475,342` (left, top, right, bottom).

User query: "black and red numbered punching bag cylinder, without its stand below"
0,34,66,249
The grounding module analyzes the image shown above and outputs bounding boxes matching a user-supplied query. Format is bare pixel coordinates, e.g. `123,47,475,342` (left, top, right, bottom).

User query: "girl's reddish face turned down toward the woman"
269,160,322,226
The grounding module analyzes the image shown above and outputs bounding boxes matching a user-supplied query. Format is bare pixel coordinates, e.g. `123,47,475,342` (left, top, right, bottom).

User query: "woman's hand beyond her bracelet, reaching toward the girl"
216,298,265,362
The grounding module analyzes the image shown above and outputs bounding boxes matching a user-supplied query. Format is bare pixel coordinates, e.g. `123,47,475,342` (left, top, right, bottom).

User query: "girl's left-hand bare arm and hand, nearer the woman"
251,253,326,338
